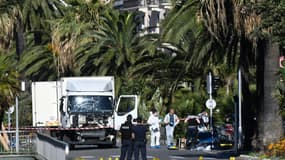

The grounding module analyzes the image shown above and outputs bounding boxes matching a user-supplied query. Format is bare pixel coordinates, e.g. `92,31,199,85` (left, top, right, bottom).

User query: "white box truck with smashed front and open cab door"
32,77,138,147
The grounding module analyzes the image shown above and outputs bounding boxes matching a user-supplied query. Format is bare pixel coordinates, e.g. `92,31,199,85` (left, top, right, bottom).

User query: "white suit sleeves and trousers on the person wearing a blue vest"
164,113,179,146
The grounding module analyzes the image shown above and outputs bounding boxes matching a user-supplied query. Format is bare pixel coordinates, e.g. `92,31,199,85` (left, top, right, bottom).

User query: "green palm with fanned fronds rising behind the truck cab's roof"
80,10,148,93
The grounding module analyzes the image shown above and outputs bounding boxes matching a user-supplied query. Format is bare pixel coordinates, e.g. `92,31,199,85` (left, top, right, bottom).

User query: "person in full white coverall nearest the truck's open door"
147,109,160,148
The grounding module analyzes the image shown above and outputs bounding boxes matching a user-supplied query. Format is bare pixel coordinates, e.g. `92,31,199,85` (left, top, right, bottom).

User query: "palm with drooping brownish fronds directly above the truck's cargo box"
51,1,110,76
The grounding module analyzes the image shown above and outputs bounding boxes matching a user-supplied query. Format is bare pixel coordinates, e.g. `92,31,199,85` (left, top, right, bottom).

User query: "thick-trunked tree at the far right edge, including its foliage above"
256,1,285,149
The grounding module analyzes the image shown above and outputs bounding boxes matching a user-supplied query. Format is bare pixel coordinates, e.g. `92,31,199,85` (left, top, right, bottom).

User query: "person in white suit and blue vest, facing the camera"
164,108,179,147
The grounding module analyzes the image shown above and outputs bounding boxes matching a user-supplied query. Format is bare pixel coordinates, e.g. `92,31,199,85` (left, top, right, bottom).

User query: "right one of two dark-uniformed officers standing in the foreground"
132,117,147,160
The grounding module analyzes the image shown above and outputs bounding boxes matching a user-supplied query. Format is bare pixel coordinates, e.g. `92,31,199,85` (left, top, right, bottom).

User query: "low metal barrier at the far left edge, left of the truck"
0,130,35,154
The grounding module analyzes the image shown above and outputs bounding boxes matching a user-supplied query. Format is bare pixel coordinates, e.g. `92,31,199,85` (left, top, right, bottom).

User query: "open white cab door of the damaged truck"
114,95,139,130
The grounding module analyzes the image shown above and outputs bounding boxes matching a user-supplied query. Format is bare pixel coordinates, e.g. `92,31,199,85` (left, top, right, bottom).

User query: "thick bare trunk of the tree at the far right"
257,41,283,150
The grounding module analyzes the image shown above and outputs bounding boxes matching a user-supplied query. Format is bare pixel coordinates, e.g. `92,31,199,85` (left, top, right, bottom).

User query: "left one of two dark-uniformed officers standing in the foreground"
120,115,133,160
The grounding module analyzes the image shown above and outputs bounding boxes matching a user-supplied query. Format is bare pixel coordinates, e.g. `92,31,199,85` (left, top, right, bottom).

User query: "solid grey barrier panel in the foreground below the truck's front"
36,133,69,160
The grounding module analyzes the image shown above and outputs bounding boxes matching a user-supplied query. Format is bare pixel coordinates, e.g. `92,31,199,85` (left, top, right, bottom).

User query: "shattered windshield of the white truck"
68,96,113,113
